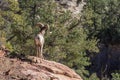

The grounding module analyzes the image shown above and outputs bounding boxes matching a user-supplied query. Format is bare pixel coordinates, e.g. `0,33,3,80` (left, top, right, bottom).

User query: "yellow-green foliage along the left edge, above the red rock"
0,0,22,51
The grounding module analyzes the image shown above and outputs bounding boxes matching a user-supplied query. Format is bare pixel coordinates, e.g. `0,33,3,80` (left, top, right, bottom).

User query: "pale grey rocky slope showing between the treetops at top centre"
55,0,86,18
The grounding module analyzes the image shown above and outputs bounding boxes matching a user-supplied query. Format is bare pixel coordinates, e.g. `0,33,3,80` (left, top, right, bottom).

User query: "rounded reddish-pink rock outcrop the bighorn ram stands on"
0,57,82,80
